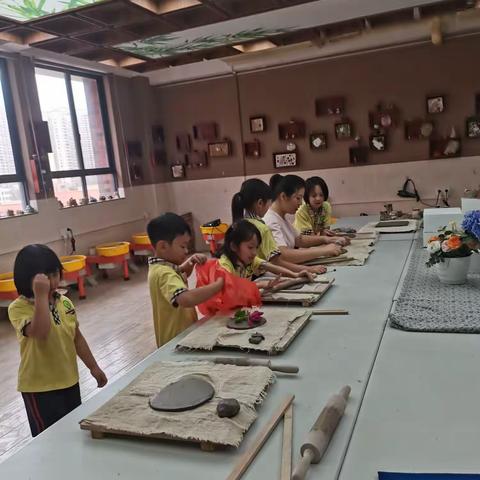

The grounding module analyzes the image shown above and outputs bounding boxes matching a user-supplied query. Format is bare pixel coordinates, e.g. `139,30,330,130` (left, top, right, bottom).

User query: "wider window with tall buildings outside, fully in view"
35,66,118,206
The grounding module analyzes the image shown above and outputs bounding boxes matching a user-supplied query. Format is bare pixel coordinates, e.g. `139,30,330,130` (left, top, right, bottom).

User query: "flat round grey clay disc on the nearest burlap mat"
150,375,215,412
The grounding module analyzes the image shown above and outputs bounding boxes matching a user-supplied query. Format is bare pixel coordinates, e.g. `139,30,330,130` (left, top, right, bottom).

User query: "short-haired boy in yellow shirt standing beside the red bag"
147,213,223,347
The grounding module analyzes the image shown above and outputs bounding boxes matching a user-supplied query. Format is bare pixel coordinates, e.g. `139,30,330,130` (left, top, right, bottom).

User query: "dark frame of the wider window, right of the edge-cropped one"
35,62,119,198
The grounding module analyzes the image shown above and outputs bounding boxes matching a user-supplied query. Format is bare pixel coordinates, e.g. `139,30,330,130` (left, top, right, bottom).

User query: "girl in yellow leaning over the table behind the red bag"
219,220,313,288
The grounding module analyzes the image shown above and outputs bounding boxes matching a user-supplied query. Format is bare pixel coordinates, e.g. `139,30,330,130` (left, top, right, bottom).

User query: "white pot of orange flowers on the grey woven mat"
427,223,477,285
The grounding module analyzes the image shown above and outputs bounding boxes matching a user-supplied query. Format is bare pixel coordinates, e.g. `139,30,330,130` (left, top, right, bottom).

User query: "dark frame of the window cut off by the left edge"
0,58,30,208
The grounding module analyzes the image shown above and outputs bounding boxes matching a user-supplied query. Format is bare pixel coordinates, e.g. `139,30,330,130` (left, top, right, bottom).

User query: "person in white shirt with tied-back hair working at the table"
264,174,349,263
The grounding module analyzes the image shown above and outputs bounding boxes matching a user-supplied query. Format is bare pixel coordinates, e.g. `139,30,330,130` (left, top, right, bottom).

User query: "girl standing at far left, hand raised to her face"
8,245,107,437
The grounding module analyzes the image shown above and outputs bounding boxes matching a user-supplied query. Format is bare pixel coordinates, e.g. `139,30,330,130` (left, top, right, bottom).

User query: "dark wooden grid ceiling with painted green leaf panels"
0,0,477,72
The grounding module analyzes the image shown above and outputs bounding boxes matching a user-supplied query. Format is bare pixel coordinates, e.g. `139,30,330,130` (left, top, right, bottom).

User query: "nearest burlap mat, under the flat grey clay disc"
81,362,275,447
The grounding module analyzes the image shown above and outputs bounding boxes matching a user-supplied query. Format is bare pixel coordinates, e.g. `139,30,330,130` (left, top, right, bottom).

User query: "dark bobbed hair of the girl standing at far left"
13,244,63,298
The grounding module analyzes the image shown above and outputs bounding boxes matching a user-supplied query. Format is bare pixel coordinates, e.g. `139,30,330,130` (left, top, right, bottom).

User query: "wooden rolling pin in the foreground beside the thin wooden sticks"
292,385,350,480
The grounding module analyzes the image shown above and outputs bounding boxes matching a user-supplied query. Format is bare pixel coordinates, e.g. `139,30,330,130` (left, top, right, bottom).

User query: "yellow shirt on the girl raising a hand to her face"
8,295,78,393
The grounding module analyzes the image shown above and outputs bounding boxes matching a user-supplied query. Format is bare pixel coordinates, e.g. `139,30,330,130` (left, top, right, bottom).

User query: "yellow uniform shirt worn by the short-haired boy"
148,258,197,347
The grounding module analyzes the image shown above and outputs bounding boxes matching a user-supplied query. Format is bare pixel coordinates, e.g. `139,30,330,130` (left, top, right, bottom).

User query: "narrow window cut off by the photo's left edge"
0,59,27,217
